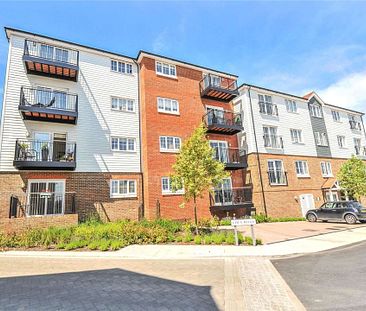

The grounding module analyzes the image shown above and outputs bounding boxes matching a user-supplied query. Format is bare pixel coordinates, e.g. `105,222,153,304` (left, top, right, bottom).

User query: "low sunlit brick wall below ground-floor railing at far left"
0,214,78,233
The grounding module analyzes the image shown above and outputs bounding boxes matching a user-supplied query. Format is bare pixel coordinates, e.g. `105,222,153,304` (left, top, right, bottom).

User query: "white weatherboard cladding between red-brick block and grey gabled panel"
235,88,316,156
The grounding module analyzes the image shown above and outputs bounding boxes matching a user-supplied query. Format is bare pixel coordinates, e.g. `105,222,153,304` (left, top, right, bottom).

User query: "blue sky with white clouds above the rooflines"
0,1,366,112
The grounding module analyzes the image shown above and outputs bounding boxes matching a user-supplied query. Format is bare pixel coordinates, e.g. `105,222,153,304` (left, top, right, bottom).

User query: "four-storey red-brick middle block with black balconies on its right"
137,51,252,219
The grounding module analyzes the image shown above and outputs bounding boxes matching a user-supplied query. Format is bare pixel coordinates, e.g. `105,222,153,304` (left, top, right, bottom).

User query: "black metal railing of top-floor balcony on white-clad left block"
24,40,79,66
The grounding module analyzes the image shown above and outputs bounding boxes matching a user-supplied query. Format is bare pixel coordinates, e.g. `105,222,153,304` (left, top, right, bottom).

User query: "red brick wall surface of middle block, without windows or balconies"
140,57,247,219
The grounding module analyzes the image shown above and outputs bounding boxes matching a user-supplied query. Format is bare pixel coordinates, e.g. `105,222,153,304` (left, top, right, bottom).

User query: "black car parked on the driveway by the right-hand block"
306,201,366,224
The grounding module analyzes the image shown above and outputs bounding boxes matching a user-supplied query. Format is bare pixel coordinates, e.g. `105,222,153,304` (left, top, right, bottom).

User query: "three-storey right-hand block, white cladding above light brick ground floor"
234,84,366,217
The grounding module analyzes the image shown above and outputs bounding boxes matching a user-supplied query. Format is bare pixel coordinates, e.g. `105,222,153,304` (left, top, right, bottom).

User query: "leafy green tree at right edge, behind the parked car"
337,156,366,200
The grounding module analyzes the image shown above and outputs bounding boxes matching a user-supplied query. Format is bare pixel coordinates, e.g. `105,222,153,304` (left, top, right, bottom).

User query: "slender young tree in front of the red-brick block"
171,123,228,234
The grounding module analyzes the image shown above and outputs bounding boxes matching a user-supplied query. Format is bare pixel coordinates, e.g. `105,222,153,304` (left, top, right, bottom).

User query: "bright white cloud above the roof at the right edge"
316,71,366,112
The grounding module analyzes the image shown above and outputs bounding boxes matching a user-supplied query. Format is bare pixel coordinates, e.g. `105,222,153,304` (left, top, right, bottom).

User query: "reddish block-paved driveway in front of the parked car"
240,221,366,244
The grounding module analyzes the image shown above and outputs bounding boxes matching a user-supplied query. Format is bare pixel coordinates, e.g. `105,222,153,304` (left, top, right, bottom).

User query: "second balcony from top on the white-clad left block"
19,87,78,124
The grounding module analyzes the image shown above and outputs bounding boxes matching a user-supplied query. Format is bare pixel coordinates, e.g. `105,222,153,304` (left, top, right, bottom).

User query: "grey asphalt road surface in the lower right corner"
272,242,366,311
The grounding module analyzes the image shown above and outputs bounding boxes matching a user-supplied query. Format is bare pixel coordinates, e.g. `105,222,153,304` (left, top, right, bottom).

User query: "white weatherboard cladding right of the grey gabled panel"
323,106,366,158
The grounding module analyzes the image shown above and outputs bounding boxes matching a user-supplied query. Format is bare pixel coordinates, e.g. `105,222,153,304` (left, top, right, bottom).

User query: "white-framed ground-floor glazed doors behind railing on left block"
26,181,65,216
